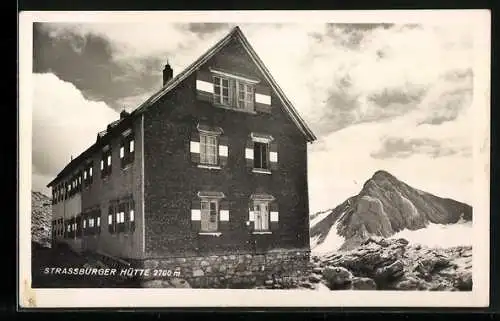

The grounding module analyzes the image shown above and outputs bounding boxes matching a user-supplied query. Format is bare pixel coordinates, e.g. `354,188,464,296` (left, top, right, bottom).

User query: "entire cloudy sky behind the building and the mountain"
32,18,480,212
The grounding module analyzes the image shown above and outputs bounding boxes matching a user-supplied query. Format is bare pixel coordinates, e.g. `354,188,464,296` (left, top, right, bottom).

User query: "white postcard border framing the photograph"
18,10,491,308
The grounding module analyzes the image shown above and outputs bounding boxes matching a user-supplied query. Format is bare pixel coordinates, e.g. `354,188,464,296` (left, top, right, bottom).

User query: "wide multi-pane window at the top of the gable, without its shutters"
213,76,255,111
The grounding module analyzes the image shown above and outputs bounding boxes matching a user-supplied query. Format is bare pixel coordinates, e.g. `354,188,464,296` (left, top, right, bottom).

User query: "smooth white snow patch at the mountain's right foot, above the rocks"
390,222,473,248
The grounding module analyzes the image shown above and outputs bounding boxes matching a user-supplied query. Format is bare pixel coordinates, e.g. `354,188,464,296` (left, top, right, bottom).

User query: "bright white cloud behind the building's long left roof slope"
32,73,119,191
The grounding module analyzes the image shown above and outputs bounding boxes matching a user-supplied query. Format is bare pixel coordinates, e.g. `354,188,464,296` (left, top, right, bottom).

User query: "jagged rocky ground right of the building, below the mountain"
309,235,472,291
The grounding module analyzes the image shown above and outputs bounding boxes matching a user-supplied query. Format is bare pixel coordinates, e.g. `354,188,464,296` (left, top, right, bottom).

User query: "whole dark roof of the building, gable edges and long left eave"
47,26,316,187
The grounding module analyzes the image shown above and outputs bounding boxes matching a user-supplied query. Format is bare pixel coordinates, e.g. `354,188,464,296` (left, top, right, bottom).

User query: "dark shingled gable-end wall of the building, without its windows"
144,37,309,257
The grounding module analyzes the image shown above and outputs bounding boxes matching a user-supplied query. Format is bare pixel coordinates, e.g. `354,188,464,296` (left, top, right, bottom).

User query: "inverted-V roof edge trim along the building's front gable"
132,26,316,142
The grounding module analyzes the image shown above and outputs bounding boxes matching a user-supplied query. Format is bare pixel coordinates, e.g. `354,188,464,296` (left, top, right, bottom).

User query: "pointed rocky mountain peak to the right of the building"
310,170,472,250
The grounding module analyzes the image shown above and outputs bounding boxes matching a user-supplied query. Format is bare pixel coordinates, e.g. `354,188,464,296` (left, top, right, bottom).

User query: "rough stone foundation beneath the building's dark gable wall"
135,250,310,288
